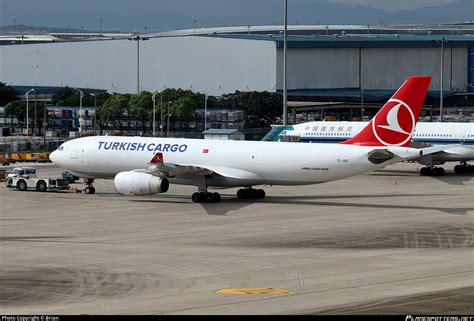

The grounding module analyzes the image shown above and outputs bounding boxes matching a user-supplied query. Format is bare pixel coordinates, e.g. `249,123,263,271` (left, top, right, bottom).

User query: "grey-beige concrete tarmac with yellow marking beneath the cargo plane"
0,163,474,315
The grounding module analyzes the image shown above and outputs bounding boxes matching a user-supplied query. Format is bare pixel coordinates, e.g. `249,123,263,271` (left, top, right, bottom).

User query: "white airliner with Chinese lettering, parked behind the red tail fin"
277,119,474,176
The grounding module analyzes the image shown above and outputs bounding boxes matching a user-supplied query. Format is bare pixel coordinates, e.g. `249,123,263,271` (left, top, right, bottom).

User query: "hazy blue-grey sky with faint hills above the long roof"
0,0,474,32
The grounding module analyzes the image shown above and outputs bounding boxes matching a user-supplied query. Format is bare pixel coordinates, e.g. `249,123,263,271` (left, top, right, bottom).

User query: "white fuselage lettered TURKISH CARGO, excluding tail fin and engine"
53,136,408,187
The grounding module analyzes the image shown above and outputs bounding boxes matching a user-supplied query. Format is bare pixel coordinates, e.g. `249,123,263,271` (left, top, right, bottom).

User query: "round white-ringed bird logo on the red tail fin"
372,99,416,146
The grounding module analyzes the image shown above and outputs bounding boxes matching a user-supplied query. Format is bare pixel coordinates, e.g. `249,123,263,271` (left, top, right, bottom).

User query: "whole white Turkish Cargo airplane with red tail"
50,76,431,202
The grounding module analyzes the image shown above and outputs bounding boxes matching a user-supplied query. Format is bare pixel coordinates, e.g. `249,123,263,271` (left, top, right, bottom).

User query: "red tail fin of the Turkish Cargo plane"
341,76,431,147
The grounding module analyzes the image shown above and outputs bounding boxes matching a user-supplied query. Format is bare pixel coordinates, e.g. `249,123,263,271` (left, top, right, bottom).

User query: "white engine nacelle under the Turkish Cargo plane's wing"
114,172,170,195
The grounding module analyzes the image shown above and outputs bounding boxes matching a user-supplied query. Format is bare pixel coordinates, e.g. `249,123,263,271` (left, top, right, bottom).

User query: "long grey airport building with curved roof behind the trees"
0,23,474,122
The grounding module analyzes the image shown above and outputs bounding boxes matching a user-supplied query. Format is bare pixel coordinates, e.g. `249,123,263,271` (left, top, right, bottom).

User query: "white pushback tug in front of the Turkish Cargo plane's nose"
6,176,69,192
